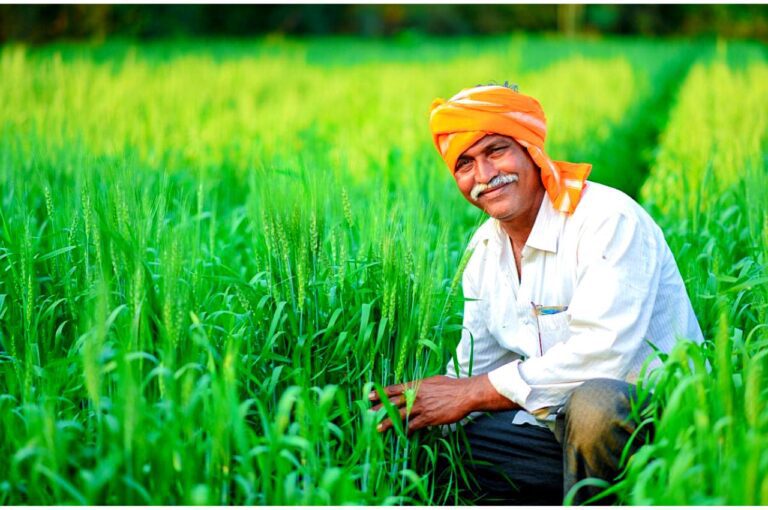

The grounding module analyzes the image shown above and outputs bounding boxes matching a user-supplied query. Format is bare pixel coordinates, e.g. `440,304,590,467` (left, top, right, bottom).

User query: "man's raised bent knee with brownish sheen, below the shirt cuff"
564,379,635,447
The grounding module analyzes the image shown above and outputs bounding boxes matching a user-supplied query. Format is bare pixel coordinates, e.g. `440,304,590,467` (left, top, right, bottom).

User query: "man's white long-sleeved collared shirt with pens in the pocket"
447,182,703,425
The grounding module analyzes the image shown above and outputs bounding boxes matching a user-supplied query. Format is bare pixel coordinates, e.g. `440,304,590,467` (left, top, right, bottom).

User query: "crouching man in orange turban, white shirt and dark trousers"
370,85,702,504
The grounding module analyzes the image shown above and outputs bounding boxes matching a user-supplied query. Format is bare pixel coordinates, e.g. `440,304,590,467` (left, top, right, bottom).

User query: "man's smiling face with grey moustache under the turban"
453,135,544,221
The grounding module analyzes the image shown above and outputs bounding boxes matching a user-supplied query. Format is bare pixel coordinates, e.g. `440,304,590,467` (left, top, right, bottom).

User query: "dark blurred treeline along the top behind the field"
0,5,768,43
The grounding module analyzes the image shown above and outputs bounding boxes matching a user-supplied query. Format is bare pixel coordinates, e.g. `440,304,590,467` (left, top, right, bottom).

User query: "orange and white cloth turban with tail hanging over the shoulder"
429,85,592,214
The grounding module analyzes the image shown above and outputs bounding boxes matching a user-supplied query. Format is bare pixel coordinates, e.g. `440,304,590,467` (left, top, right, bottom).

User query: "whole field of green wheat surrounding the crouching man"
0,36,768,505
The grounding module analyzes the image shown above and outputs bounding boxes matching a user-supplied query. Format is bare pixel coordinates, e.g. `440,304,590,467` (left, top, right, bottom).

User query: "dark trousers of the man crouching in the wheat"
448,379,652,505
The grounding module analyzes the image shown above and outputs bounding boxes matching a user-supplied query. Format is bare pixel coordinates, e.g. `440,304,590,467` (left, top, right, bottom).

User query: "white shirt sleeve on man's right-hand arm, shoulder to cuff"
489,213,661,415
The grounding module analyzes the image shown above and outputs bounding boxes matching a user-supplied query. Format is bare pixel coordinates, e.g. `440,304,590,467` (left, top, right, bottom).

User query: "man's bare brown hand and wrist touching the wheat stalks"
368,374,518,435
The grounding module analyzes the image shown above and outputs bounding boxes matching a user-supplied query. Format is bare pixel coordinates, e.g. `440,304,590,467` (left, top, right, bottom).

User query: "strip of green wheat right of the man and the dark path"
624,50,768,505
